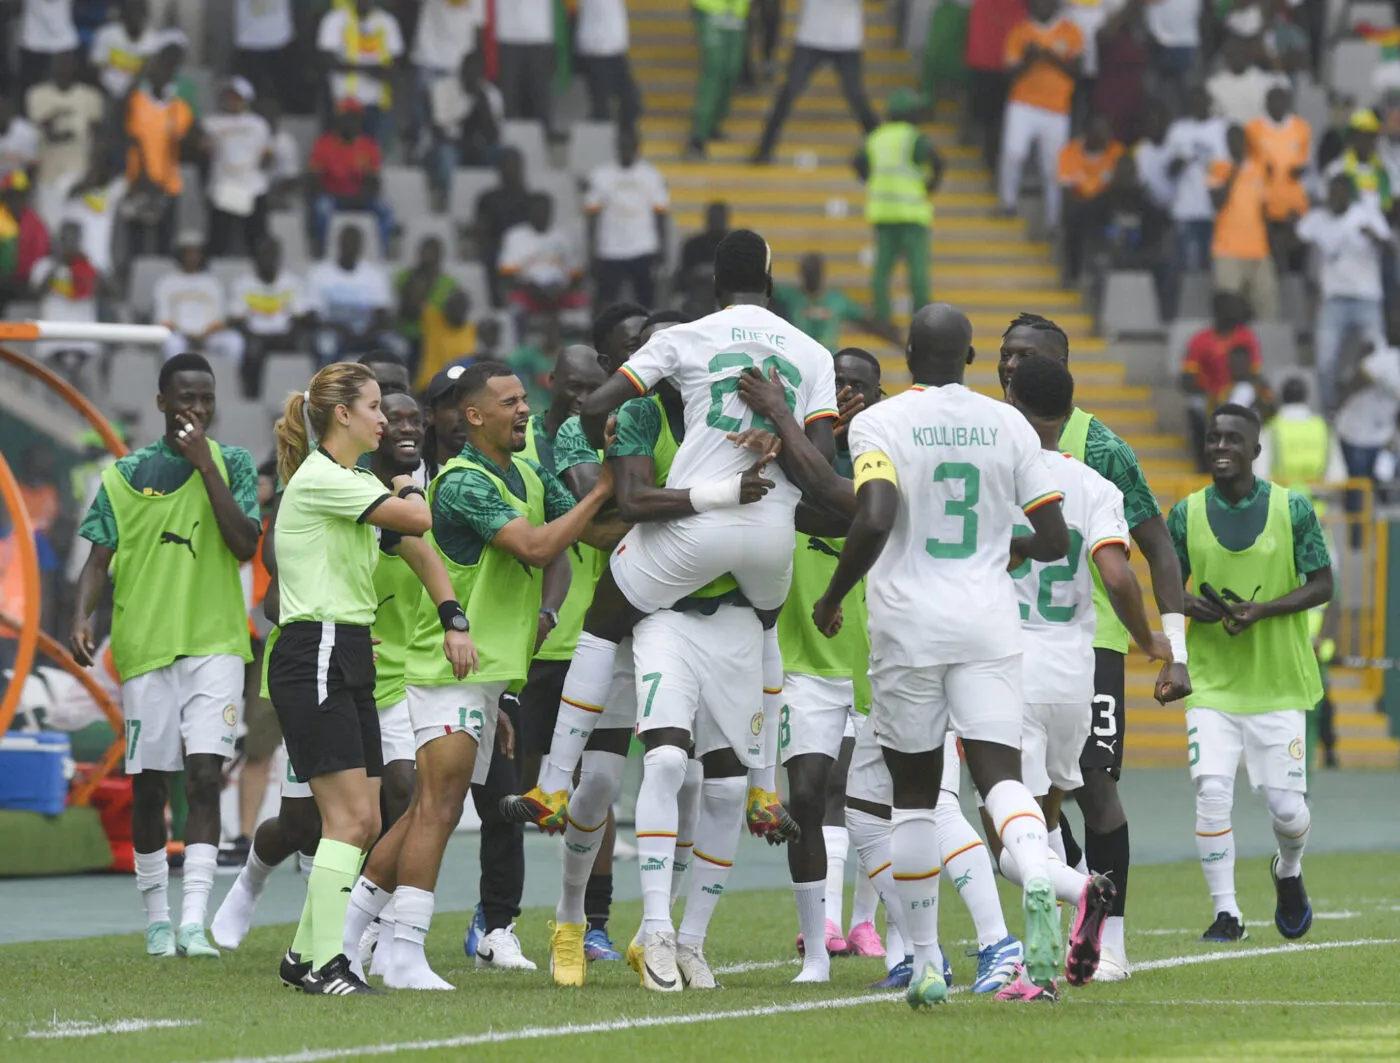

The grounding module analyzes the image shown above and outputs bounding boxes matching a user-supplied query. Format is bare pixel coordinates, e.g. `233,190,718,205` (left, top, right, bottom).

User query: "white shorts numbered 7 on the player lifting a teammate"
631,602,766,767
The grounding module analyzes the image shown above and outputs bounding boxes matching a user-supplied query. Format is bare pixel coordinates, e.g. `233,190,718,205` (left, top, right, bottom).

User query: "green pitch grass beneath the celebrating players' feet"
0,854,1400,1063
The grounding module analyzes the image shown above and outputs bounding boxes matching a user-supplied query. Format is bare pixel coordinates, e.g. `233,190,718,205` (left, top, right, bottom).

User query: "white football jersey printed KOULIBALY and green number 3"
850,384,1060,667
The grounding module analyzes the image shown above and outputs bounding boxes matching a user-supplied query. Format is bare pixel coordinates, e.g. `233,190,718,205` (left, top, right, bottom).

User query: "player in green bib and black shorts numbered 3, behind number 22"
997,314,1191,982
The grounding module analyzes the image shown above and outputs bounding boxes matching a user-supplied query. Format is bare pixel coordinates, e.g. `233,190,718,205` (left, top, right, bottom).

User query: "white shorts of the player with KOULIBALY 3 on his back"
871,654,1022,753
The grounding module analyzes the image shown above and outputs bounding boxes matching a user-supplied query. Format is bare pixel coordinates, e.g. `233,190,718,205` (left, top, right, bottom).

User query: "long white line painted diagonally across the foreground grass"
186,937,1400,1063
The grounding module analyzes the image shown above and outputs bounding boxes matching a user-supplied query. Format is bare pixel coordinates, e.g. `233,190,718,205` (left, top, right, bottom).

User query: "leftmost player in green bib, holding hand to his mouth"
71,354,260,957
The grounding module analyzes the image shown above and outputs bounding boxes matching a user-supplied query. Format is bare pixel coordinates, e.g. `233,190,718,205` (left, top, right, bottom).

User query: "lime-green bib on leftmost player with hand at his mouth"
102,440,253,682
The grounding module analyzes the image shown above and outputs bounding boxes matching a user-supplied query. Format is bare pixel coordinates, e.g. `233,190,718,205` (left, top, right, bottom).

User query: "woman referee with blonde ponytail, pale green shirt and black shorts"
267,363,466,996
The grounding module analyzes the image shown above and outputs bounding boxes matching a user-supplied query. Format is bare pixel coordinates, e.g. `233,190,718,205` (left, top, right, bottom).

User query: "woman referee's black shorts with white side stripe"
267,620,384,781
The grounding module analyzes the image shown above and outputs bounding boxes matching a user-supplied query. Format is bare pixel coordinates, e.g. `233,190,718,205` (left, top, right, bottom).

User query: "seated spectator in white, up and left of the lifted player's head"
497,192,588,336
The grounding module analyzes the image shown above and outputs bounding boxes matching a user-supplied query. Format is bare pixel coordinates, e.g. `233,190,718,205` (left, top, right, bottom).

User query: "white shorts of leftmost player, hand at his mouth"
122,654,245,774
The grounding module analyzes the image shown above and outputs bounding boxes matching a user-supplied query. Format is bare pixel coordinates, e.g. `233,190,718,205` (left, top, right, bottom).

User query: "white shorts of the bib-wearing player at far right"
1186,709,1308,793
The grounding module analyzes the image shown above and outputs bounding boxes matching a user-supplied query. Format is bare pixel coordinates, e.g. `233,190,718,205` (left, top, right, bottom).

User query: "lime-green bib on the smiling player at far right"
1186,483,1322,717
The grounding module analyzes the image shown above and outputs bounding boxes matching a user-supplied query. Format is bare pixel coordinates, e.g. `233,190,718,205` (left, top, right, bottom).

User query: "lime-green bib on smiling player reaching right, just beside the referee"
405,455,545,686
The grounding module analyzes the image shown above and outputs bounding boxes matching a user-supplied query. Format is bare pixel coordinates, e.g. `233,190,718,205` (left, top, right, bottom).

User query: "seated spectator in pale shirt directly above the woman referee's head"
307,225,403,366
